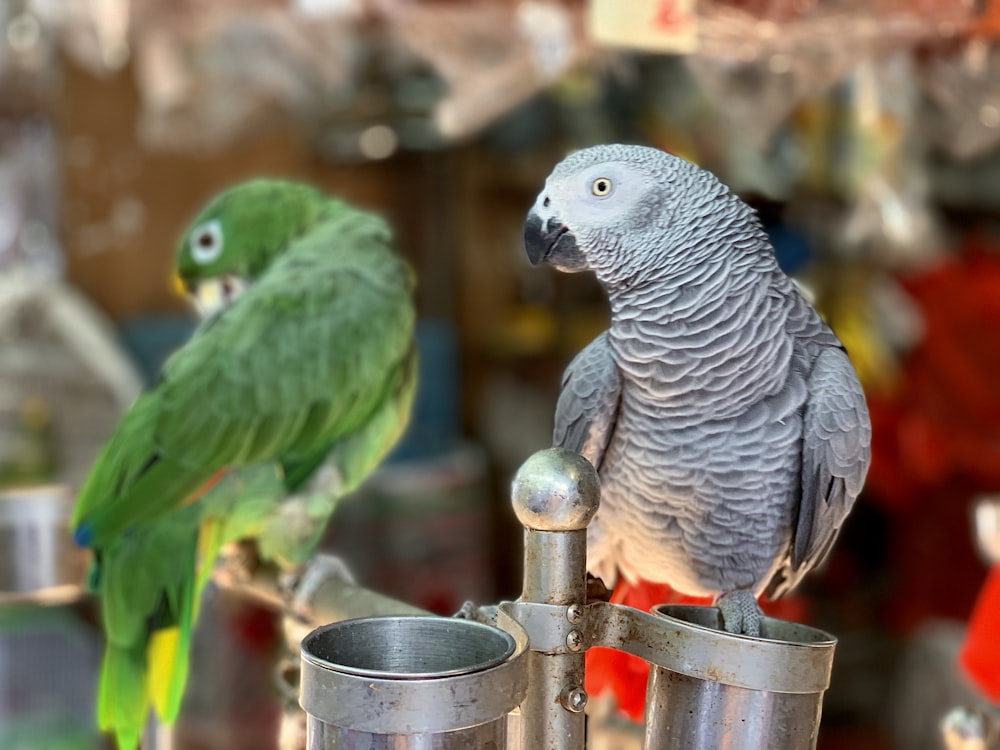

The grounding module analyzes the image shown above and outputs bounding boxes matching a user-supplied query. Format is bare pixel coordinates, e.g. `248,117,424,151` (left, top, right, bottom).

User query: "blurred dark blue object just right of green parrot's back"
389,318,461,463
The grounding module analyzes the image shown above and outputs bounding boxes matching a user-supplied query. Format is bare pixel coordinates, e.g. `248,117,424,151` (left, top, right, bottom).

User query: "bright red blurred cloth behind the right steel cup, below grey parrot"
586,580,808,721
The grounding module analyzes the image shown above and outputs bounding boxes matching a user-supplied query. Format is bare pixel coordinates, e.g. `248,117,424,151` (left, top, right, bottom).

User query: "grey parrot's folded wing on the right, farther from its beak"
778,347,872,595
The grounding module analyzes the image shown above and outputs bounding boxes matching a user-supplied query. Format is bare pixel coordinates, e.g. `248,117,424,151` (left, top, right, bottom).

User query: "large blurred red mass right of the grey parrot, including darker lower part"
865,238,1000,633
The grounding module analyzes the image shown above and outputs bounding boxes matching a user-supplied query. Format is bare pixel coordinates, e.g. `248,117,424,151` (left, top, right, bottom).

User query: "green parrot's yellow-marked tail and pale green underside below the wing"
98,340,416,749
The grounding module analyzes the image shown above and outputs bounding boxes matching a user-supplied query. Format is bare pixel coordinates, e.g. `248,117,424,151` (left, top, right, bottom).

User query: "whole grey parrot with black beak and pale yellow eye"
524,145,871,636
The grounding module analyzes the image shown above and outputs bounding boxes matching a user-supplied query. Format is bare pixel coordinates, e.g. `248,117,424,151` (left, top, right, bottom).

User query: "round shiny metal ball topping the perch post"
511,448,601,531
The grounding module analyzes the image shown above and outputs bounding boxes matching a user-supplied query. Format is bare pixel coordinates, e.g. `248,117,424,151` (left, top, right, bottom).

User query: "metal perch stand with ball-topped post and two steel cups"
300,449,836,750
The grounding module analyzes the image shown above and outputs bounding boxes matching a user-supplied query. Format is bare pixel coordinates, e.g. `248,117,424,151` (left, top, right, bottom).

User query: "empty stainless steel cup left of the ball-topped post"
299,616,527,750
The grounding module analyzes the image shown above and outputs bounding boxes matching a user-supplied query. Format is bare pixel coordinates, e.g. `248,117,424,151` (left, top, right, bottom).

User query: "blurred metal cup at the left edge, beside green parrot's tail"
0,485,89,605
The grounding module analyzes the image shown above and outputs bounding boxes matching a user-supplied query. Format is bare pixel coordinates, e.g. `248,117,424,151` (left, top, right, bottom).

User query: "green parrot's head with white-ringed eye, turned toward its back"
176,179,336,315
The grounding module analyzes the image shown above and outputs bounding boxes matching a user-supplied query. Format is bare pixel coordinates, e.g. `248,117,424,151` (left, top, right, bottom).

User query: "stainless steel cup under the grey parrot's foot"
644,605,837,750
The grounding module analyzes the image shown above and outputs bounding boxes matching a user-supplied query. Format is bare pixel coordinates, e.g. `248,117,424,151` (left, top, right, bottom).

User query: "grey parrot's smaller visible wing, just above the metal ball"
552,331,622,470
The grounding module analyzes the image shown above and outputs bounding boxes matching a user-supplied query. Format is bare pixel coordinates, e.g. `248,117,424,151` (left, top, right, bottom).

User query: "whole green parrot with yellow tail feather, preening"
72,179,417,750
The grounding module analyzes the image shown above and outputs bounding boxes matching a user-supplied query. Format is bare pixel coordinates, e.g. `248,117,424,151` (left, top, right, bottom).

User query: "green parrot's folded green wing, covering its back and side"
74,208,414,546
